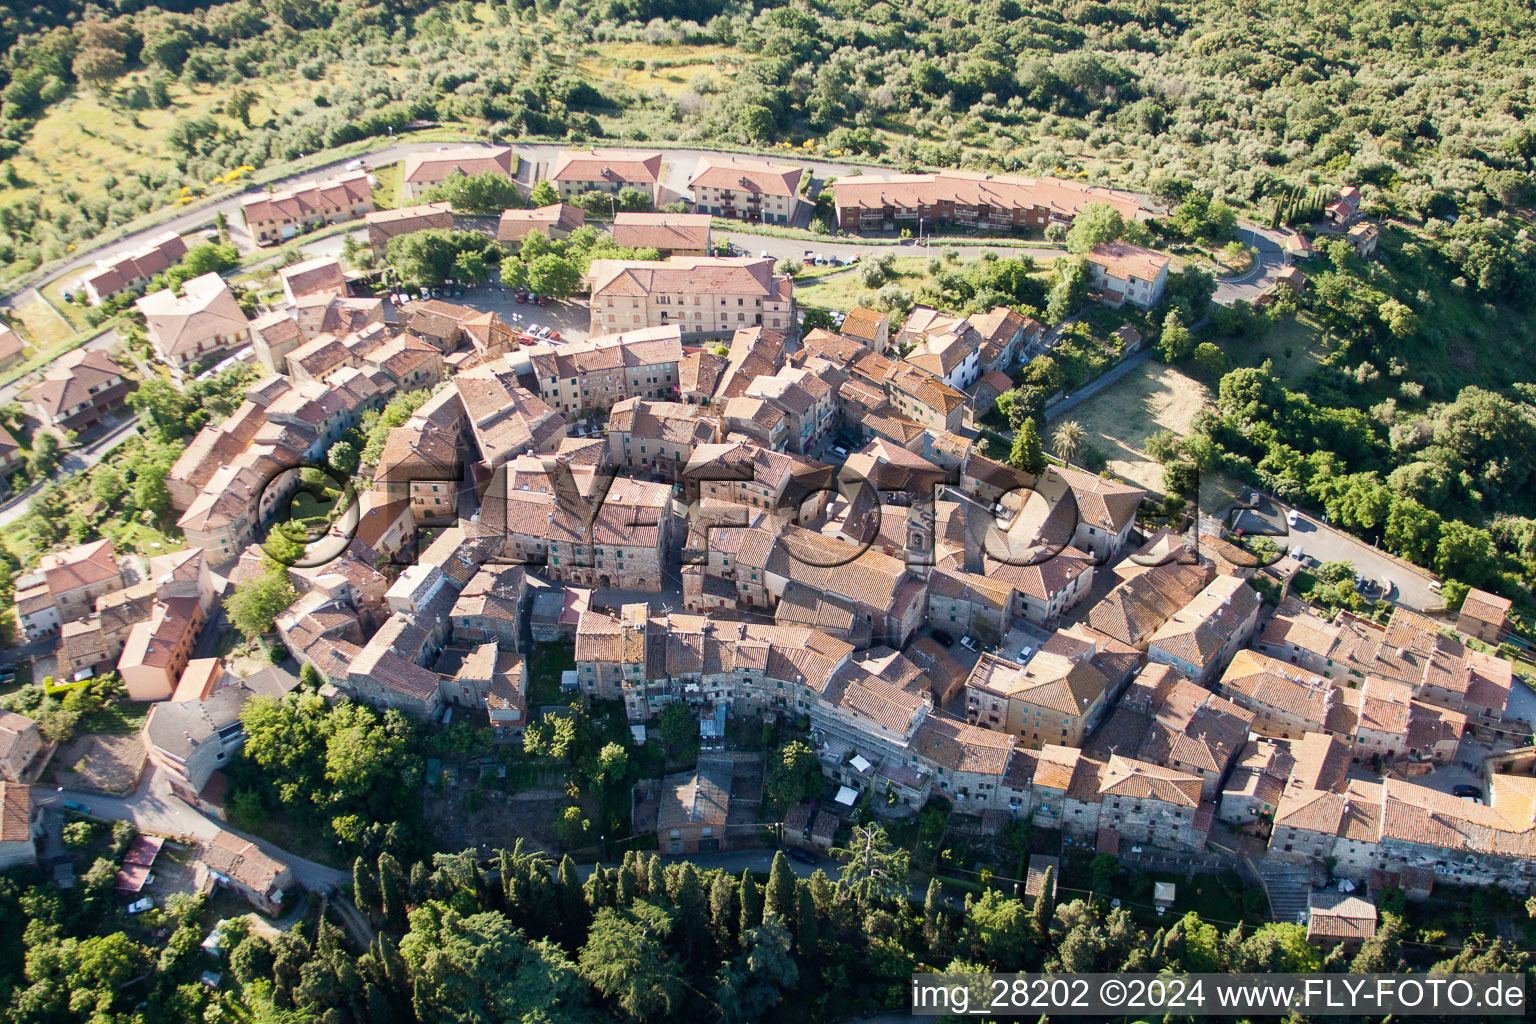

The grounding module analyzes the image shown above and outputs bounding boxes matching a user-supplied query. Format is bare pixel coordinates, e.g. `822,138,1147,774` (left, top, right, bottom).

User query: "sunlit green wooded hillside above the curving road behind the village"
0,0,1536,276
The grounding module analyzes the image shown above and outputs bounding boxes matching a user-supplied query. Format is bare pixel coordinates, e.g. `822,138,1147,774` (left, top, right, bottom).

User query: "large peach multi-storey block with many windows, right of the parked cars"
587,256,794,339
